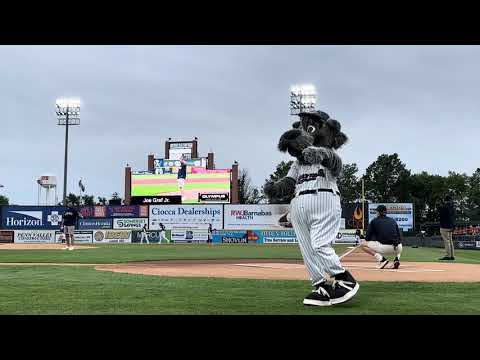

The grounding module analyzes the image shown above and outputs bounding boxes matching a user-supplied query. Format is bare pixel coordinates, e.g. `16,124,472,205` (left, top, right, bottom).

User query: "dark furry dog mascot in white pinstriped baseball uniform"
264,111,360,306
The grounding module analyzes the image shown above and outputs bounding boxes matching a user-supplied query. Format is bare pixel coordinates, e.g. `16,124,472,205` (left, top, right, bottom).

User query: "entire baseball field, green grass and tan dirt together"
0,244,480,314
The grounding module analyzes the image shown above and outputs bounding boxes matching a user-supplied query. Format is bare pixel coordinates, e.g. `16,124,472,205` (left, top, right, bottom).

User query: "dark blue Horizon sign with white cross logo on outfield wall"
2,206,65,230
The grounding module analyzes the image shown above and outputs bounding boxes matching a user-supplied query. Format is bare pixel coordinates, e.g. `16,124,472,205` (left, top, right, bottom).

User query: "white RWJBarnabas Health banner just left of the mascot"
223,204,290,230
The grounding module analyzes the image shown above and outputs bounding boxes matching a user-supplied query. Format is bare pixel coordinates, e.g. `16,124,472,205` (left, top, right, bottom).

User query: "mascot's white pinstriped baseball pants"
290,192,345,285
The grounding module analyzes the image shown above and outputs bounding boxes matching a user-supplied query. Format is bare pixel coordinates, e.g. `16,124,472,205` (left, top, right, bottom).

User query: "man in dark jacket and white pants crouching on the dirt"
360,205,402,269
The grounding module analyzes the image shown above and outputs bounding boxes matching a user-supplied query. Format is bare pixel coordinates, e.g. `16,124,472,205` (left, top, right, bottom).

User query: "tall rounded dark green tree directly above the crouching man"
363,153,411,202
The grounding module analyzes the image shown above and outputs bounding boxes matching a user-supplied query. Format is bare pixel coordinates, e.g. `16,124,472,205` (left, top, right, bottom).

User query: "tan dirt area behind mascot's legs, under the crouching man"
95,260,480,282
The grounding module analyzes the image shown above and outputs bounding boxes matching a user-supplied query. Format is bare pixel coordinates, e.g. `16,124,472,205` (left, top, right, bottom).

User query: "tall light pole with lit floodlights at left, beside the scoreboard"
56,98,80,206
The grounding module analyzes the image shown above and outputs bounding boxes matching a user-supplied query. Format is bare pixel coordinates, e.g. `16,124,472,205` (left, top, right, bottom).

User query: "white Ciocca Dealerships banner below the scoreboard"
148,205,223,230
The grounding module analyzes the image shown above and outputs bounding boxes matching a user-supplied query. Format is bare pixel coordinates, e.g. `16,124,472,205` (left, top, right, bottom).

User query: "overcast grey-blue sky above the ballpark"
0,45,480,205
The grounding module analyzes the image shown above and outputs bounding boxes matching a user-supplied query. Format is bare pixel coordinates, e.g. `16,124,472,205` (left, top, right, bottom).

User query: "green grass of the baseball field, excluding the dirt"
0,245,480,314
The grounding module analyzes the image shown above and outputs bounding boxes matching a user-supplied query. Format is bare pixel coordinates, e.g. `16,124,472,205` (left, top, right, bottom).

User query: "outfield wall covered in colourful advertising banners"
0,204,480,249
